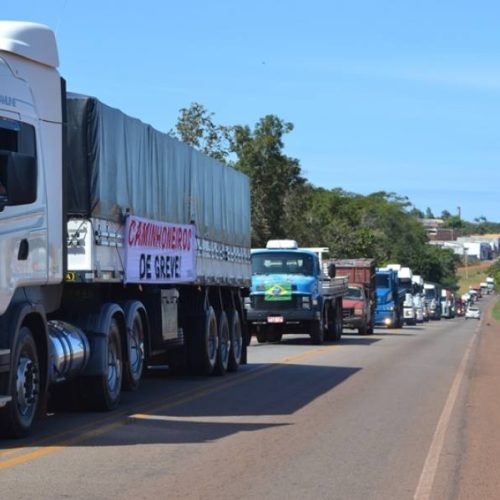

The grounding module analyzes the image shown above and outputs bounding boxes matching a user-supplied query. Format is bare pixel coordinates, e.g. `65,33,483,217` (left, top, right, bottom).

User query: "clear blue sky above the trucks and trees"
2,0,500,221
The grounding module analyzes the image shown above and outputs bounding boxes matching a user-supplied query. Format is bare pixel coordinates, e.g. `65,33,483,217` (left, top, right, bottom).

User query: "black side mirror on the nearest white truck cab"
0,151,37,210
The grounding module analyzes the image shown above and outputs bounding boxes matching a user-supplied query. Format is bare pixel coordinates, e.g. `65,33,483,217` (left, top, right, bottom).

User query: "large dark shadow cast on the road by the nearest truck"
0,364,360,450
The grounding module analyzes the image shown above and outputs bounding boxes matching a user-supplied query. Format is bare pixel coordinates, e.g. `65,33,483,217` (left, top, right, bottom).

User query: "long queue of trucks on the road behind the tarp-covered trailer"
245,240,494,344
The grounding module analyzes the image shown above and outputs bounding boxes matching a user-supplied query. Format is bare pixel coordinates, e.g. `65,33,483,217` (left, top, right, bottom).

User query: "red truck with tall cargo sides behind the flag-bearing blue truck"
332,259,376,335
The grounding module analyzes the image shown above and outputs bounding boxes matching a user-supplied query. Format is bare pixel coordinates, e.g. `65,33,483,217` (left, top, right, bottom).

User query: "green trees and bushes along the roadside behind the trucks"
170,103,500,290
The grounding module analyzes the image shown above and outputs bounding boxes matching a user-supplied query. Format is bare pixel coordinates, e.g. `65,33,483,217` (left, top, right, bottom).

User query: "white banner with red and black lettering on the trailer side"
125,215,196,283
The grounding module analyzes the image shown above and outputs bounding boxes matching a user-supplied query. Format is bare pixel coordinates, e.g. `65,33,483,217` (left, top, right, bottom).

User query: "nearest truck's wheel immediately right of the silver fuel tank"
85,318,123,411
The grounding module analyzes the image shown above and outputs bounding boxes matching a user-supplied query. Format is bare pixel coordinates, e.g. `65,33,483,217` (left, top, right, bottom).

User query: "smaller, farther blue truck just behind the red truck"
375,267,406,328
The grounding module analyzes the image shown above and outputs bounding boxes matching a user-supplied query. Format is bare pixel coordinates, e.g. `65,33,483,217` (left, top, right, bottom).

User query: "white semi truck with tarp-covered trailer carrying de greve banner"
0,21,251,437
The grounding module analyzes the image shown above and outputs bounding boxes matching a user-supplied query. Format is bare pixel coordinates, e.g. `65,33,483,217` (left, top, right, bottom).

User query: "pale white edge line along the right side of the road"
413,321,482,500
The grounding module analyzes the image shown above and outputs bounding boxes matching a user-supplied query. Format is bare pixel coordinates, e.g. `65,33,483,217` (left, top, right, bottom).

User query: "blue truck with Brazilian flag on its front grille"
245,240,347,344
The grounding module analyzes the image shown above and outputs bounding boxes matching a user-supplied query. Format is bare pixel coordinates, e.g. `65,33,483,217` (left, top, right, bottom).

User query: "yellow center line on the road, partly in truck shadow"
0,345,340,470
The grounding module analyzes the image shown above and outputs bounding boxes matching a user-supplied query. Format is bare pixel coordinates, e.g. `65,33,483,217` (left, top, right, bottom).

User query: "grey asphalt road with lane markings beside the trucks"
0,304,486,500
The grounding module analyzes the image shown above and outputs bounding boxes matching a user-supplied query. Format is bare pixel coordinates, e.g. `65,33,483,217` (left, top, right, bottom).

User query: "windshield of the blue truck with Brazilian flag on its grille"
252,252,314,276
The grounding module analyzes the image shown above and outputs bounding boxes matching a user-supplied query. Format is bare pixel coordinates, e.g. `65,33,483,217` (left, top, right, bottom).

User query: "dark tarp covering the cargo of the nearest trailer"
64,94,250,247
